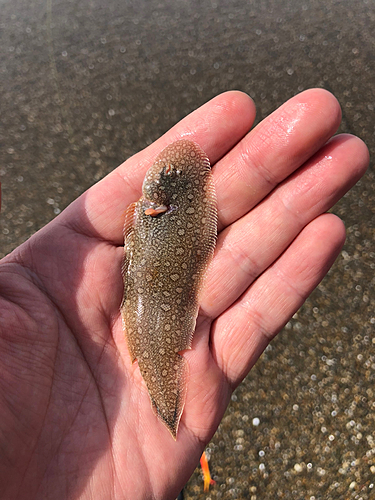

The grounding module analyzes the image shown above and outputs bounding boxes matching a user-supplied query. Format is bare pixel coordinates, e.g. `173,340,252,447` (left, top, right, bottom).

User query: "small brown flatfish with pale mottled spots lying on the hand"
121,140,217,438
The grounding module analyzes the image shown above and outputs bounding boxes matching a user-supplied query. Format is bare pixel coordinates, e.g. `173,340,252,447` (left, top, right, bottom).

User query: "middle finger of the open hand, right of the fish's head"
214,89,341,229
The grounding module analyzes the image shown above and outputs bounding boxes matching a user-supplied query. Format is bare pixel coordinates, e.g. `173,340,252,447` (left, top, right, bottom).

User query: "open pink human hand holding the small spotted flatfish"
0,89,369,500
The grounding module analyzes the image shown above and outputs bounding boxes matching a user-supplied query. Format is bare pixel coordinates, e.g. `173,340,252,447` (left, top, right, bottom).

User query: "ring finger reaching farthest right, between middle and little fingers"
201,135,368,318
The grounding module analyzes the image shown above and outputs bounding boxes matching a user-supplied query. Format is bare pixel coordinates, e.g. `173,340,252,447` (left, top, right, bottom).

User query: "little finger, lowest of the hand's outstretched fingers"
211,214,345,386
